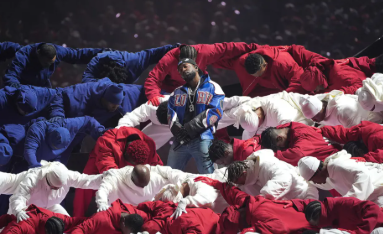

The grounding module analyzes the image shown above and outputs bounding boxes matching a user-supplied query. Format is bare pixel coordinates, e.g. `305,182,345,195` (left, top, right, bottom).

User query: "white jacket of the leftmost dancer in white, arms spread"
10,160,102,215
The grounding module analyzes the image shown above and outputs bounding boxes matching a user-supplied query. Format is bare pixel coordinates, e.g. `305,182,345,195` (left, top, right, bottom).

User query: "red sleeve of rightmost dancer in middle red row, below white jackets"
321,124,361,144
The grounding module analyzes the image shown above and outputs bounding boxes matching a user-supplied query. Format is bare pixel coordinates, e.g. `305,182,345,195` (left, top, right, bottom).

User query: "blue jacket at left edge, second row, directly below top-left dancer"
0,85,64,126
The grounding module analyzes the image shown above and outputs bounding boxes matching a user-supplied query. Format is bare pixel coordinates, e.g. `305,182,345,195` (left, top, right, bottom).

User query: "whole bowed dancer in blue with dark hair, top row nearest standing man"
82,45,177,84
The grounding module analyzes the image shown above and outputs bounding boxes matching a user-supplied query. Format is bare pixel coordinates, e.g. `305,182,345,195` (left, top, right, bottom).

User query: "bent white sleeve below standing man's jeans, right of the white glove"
183,182,218,207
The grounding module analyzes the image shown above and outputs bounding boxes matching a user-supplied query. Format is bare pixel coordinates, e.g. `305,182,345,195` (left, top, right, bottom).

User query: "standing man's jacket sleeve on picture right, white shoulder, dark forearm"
184,84,225,138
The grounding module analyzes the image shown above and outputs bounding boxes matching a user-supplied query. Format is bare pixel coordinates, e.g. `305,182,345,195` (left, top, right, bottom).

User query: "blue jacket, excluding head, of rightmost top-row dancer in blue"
82,45,175,84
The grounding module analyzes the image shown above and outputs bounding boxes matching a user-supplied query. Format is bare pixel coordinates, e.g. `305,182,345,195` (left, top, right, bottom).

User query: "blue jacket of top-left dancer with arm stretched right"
4,43,103,88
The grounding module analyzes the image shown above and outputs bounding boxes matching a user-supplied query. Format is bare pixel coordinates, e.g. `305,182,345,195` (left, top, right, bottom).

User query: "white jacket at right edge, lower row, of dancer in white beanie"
311,150,383,207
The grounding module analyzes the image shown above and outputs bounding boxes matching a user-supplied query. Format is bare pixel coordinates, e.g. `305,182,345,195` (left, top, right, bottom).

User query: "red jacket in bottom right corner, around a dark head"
292,197,383,234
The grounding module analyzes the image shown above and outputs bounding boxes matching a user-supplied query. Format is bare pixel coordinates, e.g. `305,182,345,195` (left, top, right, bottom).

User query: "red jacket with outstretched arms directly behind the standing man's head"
144,42,259,100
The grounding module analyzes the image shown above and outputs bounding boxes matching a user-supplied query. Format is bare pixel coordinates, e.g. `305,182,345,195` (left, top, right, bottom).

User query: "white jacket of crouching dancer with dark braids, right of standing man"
239,149,319,200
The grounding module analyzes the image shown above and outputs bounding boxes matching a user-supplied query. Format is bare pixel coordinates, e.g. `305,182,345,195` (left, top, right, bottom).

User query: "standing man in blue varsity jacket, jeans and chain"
168,58,225,174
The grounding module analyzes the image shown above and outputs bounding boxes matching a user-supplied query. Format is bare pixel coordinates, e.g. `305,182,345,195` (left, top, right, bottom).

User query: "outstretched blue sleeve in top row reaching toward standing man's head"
126,45,174,76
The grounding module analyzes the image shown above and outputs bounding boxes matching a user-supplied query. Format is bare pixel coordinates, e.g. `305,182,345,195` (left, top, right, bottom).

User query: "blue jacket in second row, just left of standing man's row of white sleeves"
55,78,147,124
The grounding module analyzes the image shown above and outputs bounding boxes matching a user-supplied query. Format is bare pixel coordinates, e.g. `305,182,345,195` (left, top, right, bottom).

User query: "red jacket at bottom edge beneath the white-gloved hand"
137,201,219,234
